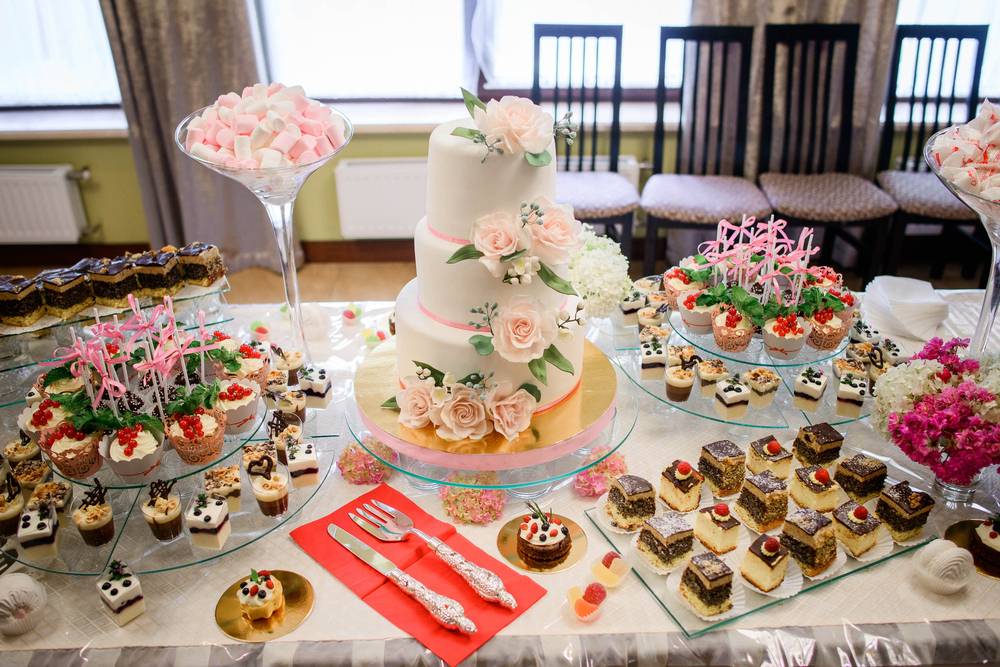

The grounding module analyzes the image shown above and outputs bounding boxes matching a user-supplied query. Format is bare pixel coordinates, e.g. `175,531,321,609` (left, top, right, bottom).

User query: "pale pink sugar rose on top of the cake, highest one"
473,95,553,153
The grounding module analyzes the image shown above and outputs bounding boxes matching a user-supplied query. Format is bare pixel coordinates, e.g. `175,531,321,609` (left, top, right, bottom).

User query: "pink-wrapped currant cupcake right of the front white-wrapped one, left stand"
166,382,226,464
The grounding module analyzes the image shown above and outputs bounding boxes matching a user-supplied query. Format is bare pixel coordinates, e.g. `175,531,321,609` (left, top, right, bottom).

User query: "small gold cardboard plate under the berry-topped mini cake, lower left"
215,570,315,642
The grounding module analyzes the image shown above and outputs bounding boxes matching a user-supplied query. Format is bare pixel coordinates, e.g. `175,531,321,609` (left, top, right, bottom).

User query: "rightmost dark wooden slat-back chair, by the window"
876,25,991,287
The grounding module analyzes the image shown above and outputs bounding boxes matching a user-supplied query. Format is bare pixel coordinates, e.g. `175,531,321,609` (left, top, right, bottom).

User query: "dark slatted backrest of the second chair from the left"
653,26,753,176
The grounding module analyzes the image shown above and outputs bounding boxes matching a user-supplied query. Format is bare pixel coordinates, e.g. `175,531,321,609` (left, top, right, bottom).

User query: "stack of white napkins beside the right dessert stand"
861,276,948,341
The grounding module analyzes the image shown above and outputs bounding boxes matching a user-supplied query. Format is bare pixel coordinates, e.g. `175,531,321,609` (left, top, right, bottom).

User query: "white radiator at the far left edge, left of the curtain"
0,164,87,243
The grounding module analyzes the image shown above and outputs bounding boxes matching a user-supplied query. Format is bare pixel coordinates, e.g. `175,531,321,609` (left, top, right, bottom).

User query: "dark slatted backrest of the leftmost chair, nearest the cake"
531,23,622,171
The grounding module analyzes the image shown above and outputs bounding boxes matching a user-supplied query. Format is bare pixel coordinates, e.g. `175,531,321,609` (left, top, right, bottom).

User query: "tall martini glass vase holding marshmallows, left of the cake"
174,107,354,360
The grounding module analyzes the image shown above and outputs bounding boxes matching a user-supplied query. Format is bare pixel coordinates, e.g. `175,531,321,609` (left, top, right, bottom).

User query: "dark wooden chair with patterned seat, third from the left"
759,24,896,283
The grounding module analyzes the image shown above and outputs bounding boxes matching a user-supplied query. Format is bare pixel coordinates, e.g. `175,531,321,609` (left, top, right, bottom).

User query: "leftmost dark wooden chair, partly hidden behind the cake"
531,24,639,257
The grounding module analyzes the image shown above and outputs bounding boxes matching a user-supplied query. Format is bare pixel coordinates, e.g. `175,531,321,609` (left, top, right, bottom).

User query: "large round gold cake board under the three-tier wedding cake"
354,340,618,454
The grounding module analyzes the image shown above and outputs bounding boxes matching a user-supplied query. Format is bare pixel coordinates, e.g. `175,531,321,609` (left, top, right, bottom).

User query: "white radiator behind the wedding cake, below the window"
335,155,639,239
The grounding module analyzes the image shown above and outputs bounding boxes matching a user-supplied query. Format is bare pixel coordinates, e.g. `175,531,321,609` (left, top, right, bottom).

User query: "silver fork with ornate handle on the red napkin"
349,500,517,609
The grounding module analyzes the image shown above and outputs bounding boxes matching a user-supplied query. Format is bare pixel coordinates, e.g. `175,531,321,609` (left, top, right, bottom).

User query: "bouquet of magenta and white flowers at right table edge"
873,338,1000,485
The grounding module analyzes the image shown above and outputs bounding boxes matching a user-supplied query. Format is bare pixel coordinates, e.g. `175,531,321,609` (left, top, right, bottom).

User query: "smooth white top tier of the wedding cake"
427,118,556,242
